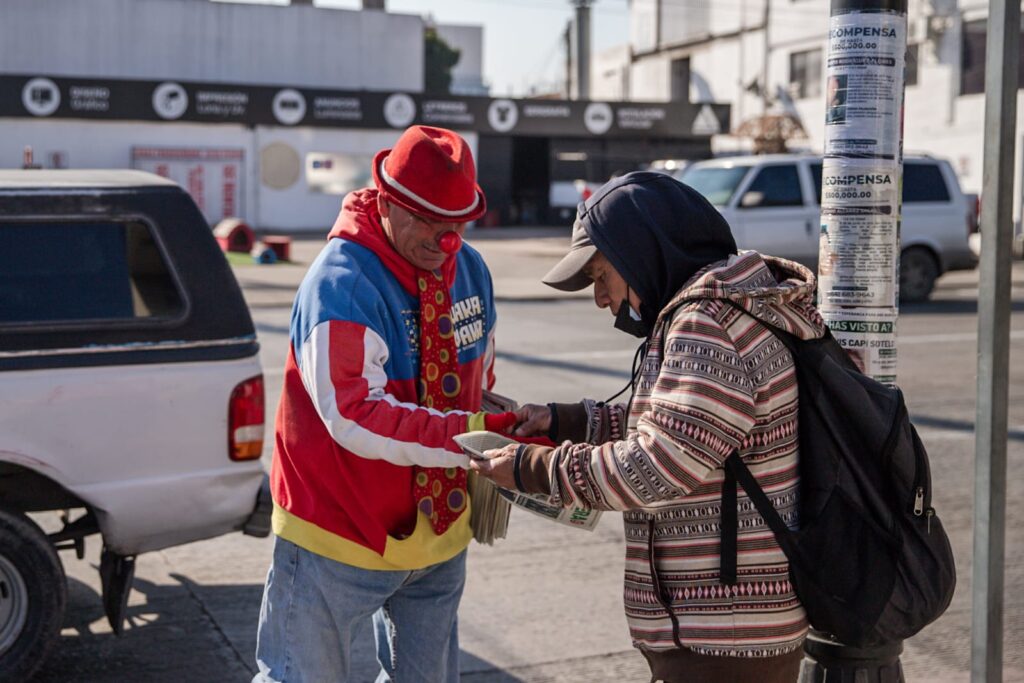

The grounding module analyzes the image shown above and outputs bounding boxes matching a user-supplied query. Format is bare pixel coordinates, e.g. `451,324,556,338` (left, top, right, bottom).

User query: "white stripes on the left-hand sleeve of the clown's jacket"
300,322,469,467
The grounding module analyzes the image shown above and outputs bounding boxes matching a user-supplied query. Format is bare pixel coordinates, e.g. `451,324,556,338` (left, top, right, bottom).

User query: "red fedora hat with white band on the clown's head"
373,126,487,223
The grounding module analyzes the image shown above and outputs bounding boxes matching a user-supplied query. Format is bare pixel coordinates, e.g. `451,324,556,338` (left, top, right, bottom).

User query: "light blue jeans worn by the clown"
253,538,466,683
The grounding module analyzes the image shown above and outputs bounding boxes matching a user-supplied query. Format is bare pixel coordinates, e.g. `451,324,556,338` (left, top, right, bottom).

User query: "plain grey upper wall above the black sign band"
0,0,423,91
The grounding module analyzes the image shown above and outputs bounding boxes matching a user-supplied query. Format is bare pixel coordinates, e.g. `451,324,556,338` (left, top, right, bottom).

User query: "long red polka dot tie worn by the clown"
413,270,467,536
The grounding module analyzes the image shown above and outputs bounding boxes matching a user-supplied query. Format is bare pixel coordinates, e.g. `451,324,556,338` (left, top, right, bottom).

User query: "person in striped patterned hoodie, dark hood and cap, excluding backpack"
471,172,824,683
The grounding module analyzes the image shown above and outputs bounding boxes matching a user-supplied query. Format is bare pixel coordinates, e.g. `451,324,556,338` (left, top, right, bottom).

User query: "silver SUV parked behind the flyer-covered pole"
680,155,978,301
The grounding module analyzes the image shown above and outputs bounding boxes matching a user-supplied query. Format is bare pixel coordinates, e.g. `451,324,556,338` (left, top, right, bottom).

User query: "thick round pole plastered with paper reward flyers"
801,0,907,682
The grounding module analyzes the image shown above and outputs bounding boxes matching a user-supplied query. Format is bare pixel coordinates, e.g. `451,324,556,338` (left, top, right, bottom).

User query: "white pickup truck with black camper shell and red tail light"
0,170,270,681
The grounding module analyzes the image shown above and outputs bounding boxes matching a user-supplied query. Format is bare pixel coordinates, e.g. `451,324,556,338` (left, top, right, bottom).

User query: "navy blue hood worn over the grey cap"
578,171,736,330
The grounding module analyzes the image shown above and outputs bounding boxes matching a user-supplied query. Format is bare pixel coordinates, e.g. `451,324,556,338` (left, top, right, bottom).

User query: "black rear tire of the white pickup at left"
0,510,68,681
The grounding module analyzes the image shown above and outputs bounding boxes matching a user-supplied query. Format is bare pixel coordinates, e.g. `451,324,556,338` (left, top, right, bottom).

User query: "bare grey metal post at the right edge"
971,0,1021,683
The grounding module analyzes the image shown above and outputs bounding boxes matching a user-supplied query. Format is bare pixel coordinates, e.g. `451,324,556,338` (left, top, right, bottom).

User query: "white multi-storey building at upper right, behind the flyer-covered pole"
592,0,1024,215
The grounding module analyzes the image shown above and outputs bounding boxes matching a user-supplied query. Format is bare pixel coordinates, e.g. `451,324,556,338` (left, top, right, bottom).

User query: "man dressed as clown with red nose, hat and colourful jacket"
254,126,514,683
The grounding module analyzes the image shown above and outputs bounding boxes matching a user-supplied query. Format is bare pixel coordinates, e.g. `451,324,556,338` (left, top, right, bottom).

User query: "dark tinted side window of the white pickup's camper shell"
0,221,184,325
